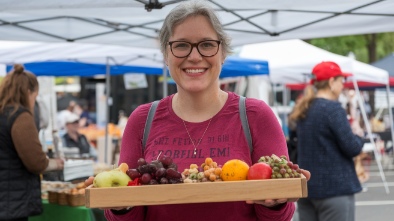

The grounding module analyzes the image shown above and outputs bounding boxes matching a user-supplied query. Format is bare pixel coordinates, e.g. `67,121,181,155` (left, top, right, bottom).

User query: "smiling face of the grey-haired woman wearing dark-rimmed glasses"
166,15,225,92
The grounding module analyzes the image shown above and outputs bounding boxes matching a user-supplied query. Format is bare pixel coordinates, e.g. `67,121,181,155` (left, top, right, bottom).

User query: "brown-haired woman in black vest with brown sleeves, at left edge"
0,64,64,221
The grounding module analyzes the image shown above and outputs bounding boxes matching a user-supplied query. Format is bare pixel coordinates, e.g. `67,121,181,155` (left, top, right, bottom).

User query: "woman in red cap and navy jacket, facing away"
290,62,363,221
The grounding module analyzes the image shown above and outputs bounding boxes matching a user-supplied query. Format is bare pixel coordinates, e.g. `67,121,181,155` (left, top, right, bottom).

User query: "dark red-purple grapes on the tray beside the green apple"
126,155,183,186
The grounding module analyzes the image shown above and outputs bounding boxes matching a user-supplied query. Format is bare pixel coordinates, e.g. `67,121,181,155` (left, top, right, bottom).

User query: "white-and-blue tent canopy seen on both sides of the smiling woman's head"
0,41,269,78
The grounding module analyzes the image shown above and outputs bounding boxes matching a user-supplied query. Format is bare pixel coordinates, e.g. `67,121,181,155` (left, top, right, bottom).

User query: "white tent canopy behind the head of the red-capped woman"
239,39,389,84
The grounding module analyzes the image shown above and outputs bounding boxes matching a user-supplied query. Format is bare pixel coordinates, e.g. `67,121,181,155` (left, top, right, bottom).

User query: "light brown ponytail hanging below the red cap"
289,80,329,121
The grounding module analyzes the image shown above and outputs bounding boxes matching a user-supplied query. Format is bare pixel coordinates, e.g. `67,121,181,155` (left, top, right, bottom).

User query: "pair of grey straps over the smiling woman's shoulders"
142,96,253,153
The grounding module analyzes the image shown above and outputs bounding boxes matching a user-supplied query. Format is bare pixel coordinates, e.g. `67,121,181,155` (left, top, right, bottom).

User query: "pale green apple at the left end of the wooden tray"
93,169,131,187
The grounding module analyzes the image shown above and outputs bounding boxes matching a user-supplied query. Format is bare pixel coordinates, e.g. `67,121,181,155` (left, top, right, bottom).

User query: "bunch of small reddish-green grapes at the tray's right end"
259,154,301,179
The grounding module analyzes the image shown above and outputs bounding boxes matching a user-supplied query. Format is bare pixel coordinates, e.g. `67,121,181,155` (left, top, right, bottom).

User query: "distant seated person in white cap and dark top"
62,113,97,159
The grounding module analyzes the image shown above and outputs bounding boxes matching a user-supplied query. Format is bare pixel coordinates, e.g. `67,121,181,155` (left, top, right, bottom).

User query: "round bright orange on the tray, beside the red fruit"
220,159,249,181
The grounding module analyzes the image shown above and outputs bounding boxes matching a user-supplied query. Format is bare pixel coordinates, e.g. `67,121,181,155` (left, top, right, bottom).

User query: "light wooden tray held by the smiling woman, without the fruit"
85,176,308,208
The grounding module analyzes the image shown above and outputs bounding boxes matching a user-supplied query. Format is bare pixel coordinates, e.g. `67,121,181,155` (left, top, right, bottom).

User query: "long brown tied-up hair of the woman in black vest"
0,64,38,113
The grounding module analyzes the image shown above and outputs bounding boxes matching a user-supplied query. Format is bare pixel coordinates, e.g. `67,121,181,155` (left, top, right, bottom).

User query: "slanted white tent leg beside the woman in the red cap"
353,78,390,194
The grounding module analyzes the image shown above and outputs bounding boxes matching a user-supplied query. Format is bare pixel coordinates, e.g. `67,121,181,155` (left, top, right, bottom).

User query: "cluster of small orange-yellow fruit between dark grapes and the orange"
182,157,222,183
